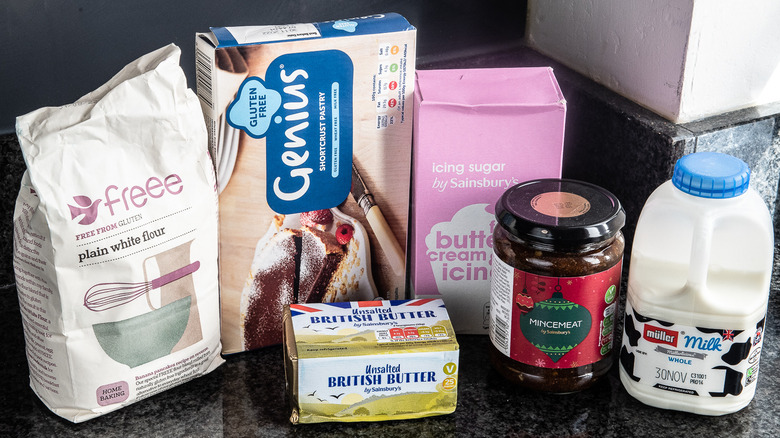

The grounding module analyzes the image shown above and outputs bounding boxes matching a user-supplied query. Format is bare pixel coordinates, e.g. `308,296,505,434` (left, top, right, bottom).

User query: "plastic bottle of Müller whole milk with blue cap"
620,152,774,415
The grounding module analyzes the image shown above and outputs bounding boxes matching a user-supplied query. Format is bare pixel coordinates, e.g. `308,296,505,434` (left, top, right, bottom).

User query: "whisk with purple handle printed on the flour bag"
84,261,200,312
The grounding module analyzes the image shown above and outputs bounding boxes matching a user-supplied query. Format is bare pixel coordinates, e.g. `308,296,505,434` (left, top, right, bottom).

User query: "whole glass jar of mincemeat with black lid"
490,179,625,393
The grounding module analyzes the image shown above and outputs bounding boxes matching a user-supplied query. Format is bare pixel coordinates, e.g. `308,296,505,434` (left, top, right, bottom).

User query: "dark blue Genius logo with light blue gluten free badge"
227,50,354,214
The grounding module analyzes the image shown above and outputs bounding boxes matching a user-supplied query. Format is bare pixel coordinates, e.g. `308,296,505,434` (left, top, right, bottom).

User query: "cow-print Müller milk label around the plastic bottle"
620,302,766,397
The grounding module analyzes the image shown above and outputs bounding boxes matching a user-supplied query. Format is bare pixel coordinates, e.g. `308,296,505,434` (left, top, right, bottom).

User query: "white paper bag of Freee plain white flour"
14,45,223,422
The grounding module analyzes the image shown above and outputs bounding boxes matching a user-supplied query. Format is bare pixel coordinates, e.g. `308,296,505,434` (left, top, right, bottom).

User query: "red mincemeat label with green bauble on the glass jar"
490,255,622,368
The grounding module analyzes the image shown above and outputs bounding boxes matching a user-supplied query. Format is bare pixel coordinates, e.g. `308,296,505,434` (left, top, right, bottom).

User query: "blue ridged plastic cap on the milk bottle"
672,152,750,199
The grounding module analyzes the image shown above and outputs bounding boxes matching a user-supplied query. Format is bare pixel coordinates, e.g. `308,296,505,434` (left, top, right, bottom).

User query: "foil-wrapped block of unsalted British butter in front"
284,300,459,423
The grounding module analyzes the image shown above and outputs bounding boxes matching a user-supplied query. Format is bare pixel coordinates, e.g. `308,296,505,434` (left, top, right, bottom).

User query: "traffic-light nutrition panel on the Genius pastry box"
371,43,408,129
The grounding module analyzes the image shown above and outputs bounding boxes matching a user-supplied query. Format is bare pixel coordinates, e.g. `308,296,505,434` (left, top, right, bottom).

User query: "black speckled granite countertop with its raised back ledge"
0,46,780,438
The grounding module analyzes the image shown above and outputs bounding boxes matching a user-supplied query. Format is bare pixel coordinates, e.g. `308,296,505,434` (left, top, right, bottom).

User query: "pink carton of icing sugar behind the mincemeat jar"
411,67,566,334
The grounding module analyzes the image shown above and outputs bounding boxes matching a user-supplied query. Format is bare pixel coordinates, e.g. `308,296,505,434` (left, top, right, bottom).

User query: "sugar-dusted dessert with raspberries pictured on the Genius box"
240,208,377,350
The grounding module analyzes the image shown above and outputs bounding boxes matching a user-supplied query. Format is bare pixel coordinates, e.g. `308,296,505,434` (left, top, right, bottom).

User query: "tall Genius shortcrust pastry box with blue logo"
196,14,416,353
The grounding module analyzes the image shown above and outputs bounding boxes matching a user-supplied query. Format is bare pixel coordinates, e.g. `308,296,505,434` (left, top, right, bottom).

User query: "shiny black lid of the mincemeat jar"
496,179,626,247
